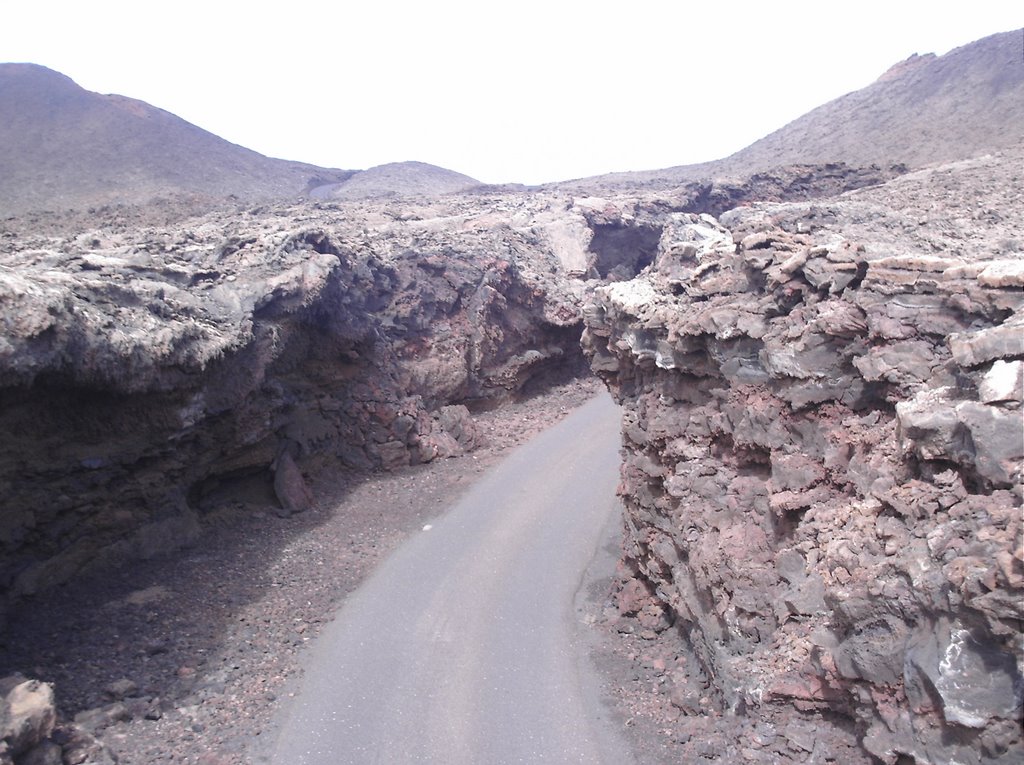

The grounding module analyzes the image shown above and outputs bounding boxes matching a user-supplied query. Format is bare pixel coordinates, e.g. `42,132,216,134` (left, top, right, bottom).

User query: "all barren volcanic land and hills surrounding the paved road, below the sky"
0,25,1024,765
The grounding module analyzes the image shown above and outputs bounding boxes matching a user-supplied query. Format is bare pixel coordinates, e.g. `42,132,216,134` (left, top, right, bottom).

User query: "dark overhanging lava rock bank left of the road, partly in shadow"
0,191,598,614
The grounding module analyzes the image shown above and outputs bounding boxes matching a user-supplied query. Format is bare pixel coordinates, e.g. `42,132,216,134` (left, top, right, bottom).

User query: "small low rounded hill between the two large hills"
311,162,480,200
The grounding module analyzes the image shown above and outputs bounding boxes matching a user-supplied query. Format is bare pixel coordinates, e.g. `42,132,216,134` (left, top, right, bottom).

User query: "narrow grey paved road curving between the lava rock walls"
273,395,632,765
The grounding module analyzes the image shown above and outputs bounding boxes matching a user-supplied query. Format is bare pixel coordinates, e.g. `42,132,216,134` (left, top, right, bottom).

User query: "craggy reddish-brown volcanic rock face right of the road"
584,151,1024,763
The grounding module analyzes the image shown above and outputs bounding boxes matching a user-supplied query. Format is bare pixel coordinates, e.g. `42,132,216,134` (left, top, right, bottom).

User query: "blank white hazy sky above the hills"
0,0,1024,183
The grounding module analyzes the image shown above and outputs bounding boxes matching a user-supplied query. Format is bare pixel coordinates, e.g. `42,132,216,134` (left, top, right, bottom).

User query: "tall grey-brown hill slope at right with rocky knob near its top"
554,30,1024,187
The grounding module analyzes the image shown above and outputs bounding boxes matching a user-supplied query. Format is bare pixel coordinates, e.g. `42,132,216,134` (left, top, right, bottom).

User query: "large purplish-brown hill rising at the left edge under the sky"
0,63,353,215
